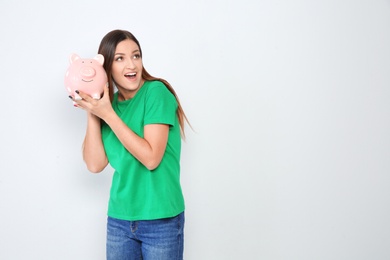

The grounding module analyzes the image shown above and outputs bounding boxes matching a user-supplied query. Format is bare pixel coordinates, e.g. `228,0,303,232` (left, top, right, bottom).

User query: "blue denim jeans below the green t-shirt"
106,212,184,260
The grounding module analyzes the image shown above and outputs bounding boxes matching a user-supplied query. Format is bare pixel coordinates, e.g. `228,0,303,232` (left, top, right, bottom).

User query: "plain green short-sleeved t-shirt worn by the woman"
102,81,184,220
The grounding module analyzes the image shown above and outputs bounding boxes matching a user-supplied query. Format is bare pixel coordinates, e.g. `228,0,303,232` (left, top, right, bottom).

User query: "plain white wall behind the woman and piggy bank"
0,0,390,260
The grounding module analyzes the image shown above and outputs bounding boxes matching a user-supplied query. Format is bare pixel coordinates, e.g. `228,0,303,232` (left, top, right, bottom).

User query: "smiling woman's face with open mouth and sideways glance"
111,40,144,99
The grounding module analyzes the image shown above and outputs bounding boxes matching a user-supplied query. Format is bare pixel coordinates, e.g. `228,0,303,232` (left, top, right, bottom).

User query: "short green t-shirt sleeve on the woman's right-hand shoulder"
144,81,177,126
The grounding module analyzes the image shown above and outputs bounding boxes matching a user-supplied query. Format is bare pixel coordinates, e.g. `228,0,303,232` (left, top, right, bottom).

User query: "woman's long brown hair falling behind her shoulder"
98,30,191,138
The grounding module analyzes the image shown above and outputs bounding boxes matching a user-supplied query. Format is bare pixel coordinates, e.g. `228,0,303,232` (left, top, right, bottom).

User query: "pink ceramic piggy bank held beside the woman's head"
65,54,108,100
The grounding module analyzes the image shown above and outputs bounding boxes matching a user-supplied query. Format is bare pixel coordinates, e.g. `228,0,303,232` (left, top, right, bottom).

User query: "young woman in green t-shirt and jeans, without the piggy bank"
72,30,187,260
